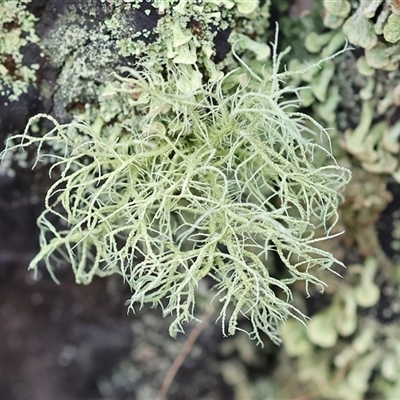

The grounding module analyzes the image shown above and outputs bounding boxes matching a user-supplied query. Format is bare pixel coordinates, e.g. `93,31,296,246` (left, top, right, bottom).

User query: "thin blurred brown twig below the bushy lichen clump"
158,304,214,400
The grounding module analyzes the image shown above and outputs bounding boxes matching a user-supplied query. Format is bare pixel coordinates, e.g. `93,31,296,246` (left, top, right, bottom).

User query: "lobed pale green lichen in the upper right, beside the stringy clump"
280,4,400,186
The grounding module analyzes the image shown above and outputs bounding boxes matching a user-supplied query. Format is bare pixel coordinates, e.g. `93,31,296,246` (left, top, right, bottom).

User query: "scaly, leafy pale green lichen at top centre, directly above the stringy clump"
105,1,228,92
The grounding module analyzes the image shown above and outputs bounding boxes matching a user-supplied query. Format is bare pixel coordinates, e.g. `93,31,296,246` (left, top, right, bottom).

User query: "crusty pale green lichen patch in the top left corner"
0,0,39,101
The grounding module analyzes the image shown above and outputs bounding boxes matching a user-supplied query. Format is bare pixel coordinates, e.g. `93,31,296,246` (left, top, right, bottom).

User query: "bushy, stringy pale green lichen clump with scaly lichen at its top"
3,1,349,343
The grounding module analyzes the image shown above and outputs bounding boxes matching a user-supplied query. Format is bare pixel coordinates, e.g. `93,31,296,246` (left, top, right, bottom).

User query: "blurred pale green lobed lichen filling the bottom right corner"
277,253,400,400
